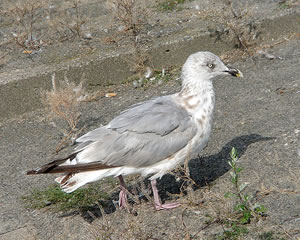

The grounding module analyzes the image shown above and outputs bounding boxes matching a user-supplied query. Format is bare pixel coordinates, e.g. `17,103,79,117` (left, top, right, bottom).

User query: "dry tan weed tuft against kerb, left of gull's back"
41,74,86,152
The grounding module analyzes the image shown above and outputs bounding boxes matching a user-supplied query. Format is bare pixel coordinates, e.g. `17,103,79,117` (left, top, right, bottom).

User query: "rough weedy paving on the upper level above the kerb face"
0,0,299,74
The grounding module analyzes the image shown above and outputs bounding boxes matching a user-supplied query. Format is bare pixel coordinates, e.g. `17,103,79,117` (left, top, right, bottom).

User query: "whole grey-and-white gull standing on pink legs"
27,52,243,210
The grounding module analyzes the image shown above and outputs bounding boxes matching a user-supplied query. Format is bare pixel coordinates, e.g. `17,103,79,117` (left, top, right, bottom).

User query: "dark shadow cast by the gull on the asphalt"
70,134,274,222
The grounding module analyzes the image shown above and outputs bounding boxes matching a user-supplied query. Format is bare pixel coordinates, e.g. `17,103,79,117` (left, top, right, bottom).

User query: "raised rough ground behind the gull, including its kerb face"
0,0,300,119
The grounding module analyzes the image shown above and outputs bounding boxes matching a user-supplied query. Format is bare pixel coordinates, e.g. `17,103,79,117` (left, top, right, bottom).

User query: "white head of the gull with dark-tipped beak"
182,52,243,85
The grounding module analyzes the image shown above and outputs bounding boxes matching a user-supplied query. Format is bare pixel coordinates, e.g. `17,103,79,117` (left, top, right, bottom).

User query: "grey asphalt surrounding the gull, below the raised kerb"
0,38,300,239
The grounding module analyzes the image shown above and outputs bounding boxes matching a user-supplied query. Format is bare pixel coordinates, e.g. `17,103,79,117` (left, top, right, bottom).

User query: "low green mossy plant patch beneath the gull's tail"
23,184,108,212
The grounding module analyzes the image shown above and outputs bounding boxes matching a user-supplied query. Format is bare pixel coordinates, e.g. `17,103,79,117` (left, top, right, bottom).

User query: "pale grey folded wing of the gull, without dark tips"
76,96,196,167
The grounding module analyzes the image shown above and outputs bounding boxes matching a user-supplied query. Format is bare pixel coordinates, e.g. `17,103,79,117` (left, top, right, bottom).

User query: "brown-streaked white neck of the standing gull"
177,81,215,118
